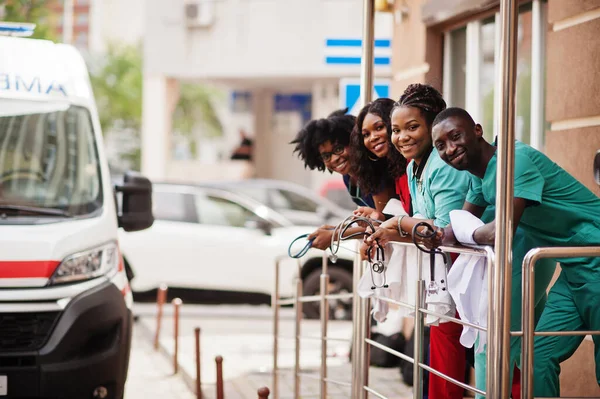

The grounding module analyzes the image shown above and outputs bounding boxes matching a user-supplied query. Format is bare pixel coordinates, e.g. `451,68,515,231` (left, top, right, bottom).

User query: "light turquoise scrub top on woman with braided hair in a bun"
406,150,471,227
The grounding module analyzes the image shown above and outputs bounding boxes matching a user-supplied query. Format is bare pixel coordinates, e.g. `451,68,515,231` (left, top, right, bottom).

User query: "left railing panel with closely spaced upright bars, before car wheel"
271,251,360,399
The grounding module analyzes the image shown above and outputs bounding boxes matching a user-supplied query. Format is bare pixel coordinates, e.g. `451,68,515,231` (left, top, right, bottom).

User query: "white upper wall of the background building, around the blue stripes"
144,0,392,84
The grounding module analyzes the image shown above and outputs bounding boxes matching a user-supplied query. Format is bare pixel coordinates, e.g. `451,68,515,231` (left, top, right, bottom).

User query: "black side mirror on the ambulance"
115,171,154,231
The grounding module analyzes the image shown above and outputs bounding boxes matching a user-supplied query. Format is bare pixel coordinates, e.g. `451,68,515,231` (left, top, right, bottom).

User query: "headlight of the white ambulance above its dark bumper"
50,243,119,284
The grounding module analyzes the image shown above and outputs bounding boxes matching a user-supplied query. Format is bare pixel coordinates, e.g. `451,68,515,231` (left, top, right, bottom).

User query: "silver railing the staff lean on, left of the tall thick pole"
272,241,494,399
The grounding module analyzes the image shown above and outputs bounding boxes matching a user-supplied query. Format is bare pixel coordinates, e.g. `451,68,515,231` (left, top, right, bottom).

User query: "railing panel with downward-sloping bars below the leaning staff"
352,242,495,399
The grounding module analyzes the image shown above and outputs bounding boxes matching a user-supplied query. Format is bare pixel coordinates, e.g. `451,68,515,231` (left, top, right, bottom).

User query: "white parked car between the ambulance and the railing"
120,183,356,319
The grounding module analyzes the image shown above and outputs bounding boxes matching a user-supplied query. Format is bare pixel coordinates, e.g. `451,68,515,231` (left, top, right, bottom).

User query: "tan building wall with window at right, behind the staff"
392,0,600,397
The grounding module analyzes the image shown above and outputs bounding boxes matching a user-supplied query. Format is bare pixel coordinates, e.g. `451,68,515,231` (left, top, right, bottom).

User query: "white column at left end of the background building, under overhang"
141,74,179,180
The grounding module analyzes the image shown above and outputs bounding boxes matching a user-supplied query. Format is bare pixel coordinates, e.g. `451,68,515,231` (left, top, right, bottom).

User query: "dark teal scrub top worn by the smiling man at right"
467,141,600,283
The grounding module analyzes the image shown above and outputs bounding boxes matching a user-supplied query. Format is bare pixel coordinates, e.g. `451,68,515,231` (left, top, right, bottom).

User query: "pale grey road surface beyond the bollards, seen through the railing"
128,304,412,399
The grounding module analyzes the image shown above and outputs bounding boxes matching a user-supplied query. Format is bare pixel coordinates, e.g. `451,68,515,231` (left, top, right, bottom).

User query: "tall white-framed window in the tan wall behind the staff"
444,0,546,149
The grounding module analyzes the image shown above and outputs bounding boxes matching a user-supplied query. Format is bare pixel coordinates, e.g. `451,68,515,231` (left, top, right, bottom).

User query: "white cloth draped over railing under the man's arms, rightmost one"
448,211,488,353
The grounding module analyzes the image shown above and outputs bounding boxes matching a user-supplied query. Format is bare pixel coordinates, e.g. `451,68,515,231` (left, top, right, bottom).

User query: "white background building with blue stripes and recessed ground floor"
142,0,392,188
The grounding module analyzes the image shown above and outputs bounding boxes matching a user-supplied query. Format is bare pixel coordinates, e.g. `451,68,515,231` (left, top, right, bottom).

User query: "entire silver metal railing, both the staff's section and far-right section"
273,242,600,399
